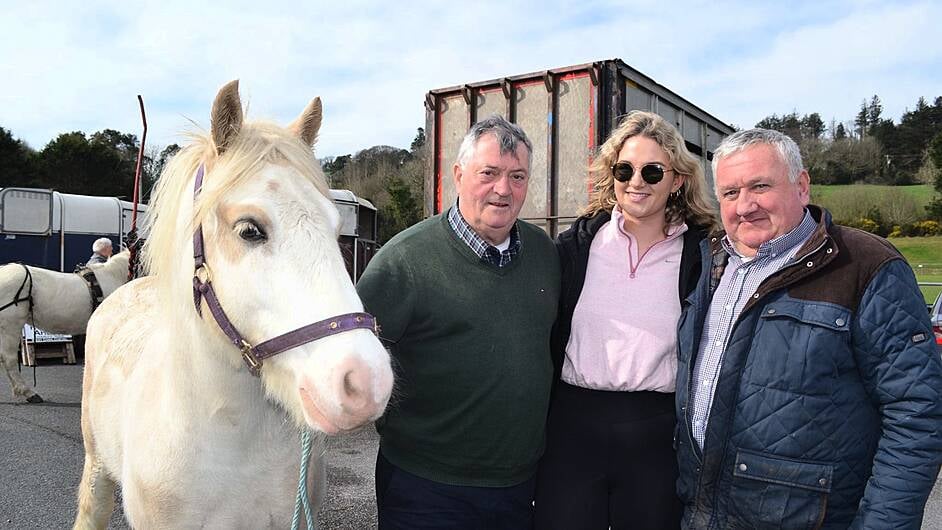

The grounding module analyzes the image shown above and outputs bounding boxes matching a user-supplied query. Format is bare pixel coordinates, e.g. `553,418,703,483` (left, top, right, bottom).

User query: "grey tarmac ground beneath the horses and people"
0,363,942,530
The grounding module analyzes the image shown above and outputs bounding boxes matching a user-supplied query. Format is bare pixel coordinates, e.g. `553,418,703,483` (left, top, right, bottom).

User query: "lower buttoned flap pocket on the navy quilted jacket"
729,450,834,530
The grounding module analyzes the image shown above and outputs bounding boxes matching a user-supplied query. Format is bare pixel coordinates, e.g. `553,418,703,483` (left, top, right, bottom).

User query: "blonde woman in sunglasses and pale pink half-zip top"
535,111,715,530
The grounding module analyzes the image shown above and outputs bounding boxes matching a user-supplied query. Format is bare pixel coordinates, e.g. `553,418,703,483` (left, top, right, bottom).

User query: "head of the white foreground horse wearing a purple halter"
145,81,392,433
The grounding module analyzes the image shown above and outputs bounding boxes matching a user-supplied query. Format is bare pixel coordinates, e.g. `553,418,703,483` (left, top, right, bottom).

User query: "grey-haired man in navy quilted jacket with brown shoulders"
676,129,942,529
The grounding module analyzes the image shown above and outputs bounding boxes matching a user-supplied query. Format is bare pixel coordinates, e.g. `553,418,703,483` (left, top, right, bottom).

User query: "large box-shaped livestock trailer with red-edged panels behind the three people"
425,59,734,236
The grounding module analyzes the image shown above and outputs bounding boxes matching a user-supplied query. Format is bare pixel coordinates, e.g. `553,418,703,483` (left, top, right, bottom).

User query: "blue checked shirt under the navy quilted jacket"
690,210,817,449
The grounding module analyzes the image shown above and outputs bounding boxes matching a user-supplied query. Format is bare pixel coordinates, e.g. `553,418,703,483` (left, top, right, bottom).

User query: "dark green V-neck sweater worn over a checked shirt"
357,215,560,487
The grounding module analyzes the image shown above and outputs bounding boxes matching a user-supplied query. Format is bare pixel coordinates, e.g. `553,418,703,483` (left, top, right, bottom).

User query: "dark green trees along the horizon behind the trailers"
0,95,942,242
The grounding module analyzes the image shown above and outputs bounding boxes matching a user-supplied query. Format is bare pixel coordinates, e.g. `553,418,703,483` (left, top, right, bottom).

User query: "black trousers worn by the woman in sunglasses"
535,382,683,530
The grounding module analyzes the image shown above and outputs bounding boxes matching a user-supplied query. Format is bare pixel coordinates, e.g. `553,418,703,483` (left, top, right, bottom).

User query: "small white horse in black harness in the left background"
0,251,128,403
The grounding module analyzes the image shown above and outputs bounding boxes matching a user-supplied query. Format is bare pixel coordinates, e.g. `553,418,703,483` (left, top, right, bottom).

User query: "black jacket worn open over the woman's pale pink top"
550,208,708,381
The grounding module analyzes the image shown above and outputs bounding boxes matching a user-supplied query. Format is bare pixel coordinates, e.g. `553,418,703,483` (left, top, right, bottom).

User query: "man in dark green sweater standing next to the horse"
357,116,559,530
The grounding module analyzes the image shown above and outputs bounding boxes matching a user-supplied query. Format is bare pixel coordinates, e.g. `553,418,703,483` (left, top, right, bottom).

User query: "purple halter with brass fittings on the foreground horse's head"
193,164,379,376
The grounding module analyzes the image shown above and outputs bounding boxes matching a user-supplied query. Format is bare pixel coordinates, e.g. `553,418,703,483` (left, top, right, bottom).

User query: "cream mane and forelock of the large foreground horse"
142,122,329,281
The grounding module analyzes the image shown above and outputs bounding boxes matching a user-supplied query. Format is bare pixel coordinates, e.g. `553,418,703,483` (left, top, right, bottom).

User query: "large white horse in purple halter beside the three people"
75,81,392,529
